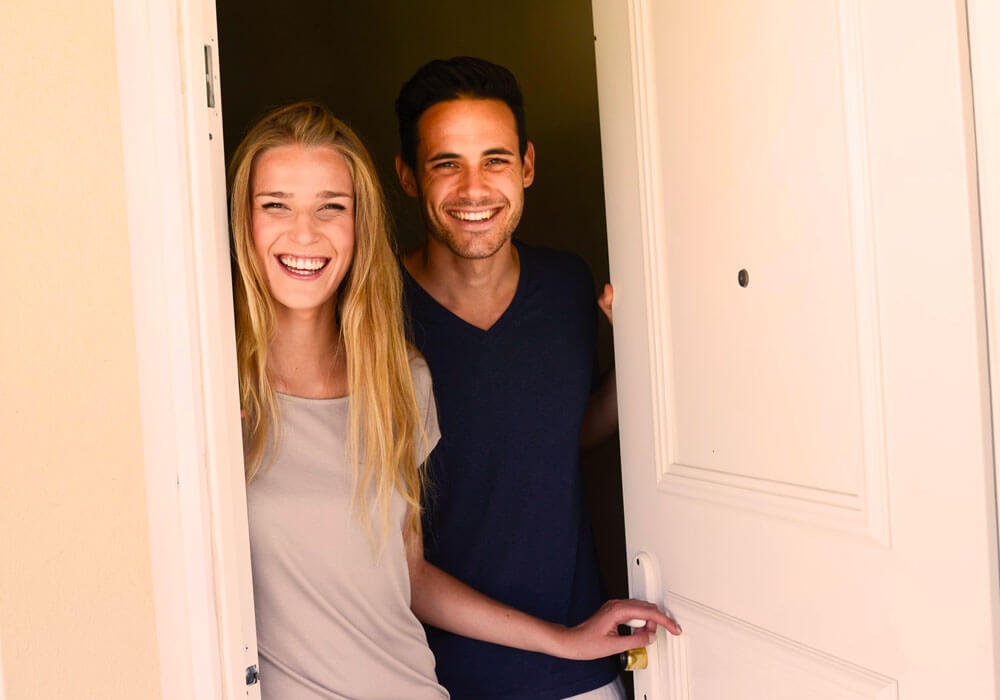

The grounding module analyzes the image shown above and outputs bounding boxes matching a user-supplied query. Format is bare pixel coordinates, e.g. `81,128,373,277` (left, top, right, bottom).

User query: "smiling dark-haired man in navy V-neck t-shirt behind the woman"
396,57,668,700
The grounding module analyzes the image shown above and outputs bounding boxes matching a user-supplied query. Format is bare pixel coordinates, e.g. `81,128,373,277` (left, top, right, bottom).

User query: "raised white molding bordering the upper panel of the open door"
627,0,891,546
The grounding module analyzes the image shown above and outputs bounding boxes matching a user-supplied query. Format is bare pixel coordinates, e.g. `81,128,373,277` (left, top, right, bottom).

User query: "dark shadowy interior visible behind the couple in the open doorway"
216,0,627,596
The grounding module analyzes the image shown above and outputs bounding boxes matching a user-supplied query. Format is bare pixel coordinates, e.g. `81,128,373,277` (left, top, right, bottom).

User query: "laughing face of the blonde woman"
250,144,354,313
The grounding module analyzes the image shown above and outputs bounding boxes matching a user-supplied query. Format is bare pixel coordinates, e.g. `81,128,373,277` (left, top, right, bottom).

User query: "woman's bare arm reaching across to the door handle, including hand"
407,524,681,659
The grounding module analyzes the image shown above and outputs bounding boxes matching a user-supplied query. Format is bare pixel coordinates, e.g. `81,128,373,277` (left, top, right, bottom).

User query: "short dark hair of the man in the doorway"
396,56,528,168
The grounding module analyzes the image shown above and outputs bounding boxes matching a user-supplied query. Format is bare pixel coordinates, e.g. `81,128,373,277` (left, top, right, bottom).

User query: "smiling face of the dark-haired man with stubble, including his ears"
396,99,535,259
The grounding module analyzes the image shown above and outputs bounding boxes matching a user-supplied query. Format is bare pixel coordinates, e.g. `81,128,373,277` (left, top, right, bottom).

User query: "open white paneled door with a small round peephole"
594,0,1000,700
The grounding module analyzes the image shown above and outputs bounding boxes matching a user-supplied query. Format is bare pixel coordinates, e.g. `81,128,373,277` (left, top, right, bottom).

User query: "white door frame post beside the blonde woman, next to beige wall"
114,0,260,700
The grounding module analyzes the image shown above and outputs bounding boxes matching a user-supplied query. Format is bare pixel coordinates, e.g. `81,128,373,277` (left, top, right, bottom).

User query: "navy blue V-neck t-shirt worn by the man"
403,243,617,700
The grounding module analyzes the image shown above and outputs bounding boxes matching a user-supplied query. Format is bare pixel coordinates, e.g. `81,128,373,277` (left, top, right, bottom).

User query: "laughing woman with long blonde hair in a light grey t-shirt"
230,103,675,700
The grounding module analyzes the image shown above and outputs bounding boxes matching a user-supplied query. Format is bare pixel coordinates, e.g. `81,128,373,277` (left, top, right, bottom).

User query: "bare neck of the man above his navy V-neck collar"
403,238,521,330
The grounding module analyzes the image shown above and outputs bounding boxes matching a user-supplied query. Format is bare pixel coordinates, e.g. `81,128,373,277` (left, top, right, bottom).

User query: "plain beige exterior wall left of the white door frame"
0,0,160,700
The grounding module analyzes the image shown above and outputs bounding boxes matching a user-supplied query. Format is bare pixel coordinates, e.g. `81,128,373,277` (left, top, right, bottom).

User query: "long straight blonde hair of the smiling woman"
229,102,426,543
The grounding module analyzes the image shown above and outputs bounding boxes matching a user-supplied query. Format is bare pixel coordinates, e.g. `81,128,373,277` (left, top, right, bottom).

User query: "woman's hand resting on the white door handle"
558,600,681,659
